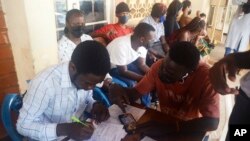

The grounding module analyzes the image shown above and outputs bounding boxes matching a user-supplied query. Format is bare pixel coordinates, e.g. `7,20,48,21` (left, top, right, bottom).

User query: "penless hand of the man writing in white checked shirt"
91,102,110,123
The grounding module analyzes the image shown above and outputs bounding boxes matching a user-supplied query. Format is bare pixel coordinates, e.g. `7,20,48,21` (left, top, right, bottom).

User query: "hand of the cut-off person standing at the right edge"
209,55,238,94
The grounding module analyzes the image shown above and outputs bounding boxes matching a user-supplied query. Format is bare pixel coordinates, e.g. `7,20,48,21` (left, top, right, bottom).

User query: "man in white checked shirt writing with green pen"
17,41,110,140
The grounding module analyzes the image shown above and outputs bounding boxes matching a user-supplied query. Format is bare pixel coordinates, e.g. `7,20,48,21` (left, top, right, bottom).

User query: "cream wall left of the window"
2,0,57,92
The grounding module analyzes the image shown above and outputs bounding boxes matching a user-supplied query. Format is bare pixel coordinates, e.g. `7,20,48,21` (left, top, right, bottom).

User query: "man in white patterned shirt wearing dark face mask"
58,9,93,62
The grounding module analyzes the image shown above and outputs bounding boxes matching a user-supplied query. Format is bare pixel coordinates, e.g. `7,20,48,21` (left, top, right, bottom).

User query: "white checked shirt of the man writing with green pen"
17,62,94,140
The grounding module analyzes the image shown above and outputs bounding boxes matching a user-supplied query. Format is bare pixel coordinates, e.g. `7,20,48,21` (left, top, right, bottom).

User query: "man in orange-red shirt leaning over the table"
110,42,219,133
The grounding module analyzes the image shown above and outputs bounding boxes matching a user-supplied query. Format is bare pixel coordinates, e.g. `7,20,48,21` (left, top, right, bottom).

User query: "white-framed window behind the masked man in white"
54,0,108,40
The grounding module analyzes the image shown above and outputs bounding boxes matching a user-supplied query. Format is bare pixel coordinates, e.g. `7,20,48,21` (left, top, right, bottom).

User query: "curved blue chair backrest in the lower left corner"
1,93,23,141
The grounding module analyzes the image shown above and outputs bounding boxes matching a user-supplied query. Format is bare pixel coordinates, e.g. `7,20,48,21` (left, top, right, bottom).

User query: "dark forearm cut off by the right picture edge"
233,51,250,69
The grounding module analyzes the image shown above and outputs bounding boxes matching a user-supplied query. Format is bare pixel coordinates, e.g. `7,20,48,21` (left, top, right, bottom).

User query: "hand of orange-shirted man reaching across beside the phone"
109,84,129,112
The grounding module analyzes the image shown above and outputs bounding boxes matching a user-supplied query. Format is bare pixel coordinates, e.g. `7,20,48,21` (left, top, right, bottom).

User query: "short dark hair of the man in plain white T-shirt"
133,23,155,37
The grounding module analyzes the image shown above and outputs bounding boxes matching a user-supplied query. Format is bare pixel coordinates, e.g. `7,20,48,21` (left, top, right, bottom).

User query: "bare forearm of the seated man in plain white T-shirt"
117,66,143,82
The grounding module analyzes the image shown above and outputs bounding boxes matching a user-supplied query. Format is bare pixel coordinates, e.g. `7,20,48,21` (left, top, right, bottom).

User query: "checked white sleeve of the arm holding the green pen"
17,83,57,140
